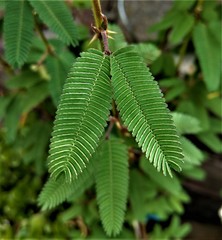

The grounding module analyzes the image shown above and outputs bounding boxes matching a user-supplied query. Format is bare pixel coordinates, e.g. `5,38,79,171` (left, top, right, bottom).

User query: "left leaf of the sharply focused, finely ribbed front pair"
49,50,112,181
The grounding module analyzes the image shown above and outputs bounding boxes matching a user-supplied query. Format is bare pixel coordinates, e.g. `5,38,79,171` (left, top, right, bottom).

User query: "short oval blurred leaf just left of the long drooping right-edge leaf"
169,13,194,44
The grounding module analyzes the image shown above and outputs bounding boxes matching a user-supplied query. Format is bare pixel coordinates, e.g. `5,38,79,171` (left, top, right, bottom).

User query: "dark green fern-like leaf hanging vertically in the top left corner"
4,0,34,68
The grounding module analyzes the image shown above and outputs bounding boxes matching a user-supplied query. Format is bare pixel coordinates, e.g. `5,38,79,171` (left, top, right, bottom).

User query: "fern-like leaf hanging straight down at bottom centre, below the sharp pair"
96,138,129,236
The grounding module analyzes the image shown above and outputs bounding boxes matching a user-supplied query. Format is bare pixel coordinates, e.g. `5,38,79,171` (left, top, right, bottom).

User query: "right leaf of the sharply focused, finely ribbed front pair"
111,47,183,175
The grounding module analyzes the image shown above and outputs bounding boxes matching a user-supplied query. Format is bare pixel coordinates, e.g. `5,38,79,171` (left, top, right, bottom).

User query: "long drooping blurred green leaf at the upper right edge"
193,23,221,91
